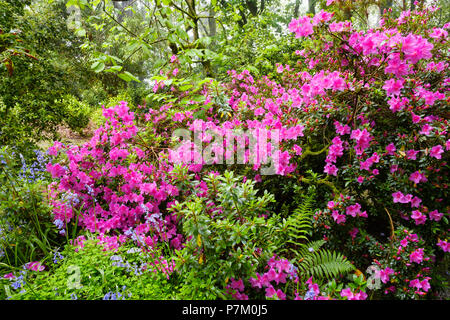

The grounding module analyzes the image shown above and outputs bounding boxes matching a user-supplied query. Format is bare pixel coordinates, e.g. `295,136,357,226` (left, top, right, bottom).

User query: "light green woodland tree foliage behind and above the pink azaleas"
0,0,449,152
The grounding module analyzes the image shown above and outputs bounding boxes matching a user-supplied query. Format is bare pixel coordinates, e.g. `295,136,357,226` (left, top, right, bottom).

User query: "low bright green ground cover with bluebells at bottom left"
0,238,176,300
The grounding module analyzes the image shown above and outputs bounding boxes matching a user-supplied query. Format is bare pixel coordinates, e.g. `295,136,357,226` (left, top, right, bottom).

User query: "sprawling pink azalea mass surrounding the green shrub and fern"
40,1,450,300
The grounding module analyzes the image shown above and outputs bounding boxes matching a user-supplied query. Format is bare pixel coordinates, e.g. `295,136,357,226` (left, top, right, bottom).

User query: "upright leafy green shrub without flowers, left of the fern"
170,171,279,299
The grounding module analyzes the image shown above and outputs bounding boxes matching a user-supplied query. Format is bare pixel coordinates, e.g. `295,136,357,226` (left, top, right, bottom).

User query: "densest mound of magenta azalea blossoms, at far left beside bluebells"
47,102,181,248
